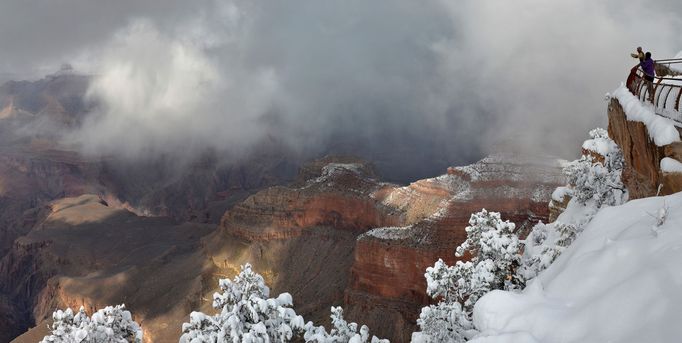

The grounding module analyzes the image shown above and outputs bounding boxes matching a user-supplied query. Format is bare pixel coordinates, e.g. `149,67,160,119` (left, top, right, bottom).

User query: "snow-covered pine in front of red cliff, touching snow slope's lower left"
412,209,524,343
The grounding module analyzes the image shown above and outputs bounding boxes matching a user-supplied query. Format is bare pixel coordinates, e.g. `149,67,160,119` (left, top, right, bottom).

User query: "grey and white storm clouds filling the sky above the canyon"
0,0,682,180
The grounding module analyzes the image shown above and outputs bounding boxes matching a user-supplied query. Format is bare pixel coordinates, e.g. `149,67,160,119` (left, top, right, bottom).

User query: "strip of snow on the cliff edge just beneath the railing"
610,84,680,146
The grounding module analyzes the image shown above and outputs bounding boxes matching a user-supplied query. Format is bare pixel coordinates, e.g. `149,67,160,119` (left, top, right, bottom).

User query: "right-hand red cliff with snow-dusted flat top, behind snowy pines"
344,155,563,342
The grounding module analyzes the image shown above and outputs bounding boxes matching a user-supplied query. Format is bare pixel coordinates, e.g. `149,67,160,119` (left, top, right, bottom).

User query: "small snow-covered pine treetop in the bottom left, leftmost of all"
40,305,142,343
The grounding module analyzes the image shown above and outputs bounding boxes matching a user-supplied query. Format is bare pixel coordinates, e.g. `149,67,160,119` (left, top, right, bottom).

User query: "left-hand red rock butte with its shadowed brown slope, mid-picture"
205,158,404,322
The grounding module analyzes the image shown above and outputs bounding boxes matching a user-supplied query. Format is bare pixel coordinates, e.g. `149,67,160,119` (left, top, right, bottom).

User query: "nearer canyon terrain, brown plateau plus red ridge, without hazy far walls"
0,155,562,342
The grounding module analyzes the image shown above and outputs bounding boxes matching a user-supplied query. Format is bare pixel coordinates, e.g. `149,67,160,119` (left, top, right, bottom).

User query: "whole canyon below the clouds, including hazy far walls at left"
0,75,564,342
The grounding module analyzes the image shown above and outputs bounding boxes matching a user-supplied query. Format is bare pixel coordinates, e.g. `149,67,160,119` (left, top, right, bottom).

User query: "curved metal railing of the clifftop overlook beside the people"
627,59,682,124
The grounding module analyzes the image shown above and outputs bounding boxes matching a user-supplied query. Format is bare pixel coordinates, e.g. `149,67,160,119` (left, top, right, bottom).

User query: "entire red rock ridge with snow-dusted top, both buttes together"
205,155,563,342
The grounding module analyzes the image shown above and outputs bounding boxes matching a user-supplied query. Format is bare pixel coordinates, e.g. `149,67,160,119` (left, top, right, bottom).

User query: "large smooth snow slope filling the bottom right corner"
472,193,682,343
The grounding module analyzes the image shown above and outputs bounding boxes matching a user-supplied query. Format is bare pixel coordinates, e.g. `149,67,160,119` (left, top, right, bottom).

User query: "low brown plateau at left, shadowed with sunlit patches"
0,195,213,341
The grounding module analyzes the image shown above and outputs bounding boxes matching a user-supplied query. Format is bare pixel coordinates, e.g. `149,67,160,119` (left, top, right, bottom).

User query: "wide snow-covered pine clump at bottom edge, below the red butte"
180,264,388,343
